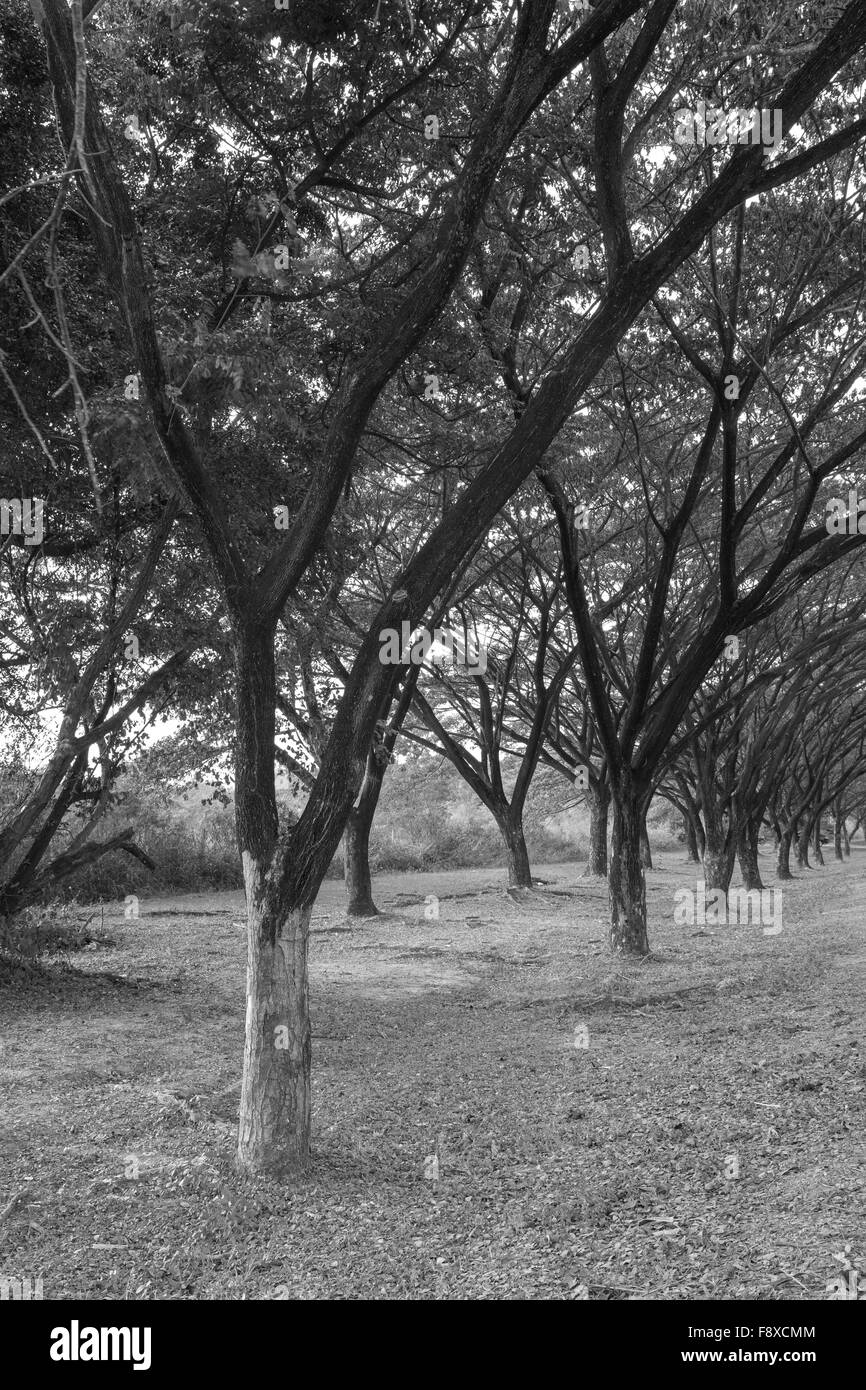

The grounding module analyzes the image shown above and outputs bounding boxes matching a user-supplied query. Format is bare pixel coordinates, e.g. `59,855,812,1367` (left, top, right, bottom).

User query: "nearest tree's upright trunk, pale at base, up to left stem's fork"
232,625,311,1175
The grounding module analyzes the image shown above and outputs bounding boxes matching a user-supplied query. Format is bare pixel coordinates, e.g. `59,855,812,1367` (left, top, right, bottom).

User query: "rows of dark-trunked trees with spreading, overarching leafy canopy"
0,0,866,1170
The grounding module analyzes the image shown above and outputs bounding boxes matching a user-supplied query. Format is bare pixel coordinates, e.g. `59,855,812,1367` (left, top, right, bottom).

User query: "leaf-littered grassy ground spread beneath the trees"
0,848,866,1300
